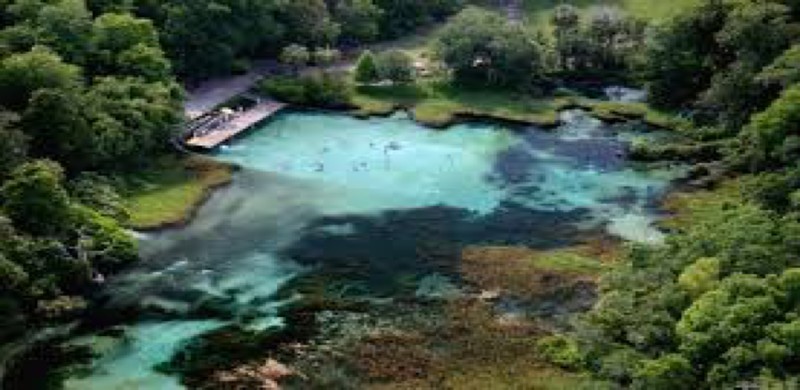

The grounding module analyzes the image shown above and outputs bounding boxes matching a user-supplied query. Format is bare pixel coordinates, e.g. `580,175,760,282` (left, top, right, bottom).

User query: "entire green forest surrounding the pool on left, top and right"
0,0,800,389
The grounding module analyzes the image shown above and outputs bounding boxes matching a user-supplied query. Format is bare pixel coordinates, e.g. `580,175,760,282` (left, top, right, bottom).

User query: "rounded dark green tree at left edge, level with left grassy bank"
0,160,70,235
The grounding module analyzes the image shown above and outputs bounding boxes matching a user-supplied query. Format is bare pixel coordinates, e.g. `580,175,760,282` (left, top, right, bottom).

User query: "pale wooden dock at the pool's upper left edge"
185,101,286,150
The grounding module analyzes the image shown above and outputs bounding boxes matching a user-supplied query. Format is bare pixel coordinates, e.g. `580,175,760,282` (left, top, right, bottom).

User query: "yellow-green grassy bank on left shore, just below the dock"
123,156,234,230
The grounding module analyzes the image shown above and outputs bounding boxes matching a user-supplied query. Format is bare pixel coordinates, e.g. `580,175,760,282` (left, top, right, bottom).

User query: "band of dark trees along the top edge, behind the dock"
89,0,462,80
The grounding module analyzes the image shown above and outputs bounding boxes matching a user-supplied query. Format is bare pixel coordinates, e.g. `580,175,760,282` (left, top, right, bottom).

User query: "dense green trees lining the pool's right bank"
540,0,800,389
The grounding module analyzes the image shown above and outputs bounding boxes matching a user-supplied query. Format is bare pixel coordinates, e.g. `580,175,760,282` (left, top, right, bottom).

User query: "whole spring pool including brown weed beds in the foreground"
53,111,674,389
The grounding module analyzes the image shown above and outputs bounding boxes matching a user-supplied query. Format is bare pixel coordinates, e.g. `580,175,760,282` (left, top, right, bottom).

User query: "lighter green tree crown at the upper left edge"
0,47,80,110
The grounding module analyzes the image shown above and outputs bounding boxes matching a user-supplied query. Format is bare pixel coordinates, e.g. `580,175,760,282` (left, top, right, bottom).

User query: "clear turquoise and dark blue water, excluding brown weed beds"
59,111,680,389
